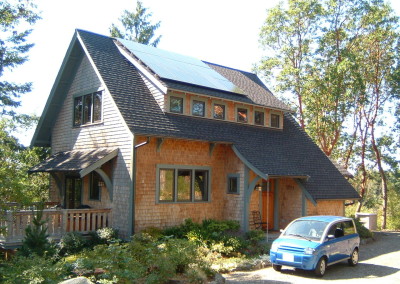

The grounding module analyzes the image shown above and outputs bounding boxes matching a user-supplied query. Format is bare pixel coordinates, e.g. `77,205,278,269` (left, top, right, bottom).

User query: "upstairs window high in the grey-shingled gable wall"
74,91,102,126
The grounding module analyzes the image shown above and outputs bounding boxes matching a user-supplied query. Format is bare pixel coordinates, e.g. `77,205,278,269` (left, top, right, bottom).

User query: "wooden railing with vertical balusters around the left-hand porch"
0,209,111,246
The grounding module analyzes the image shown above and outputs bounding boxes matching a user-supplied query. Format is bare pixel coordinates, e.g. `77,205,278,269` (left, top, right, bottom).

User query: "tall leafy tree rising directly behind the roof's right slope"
258,0,322,128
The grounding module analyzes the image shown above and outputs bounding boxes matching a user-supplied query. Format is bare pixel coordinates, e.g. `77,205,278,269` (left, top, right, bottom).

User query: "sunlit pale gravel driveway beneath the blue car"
224,232,400,284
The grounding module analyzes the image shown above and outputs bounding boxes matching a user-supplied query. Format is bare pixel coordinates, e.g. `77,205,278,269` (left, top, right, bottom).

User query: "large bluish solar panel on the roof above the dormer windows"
118,39,243,94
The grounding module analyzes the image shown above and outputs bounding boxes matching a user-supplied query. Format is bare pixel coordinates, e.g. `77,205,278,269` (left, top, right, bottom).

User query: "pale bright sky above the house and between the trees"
5,0,400,145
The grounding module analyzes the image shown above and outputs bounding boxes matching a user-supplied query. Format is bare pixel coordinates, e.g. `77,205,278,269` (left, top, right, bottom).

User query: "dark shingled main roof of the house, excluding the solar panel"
33,30,359,202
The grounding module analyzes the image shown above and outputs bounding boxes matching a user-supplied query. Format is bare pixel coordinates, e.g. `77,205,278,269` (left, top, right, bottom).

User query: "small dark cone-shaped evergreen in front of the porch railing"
19,203,55,256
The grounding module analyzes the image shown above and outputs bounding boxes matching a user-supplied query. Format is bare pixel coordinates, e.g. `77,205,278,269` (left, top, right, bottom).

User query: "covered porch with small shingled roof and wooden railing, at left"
0,148,119,248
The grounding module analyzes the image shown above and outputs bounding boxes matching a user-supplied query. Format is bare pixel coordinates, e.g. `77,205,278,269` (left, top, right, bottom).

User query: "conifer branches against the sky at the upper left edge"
0,0,40,116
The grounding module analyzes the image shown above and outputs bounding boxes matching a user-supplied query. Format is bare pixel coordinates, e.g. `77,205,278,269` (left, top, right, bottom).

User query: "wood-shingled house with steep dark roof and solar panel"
0,30,359,245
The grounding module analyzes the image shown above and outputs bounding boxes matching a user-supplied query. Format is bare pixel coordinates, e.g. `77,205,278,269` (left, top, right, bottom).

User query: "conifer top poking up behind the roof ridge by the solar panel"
110,1,161,47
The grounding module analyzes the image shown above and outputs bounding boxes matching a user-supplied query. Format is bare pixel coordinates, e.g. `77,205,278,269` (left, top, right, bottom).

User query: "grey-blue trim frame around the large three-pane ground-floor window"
155,164,212,204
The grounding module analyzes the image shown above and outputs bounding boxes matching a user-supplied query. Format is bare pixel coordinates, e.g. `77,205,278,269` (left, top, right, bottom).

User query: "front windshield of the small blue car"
284,220,328,241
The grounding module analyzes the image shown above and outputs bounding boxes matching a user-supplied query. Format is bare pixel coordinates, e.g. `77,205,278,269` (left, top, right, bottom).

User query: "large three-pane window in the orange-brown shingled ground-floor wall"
157,166,210,202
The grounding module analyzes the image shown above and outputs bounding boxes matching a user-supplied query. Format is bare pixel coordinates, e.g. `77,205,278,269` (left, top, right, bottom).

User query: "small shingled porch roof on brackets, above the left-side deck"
29,148,118,177
